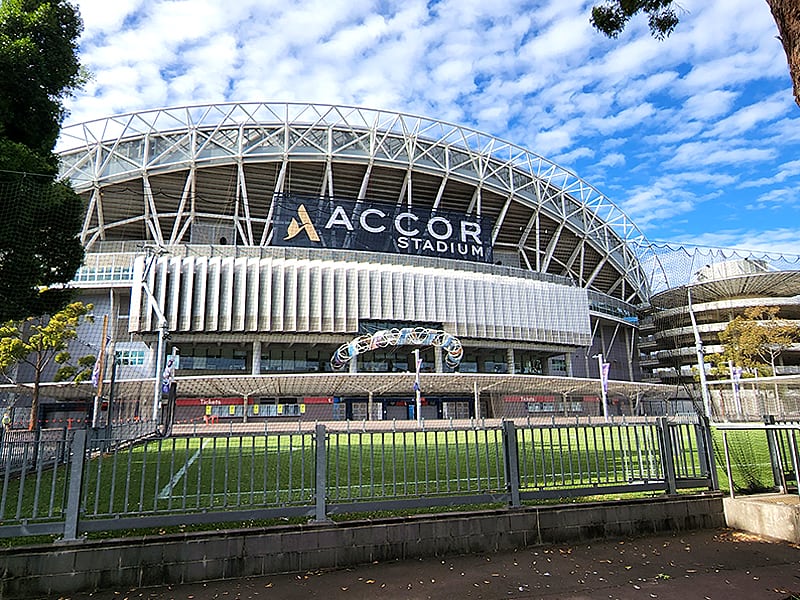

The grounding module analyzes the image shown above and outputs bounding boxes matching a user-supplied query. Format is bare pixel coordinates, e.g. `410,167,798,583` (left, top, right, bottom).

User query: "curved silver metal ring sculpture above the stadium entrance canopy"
331,327,464,370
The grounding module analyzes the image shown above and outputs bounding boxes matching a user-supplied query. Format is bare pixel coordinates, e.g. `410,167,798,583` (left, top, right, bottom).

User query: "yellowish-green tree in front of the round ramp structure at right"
719,306,800,375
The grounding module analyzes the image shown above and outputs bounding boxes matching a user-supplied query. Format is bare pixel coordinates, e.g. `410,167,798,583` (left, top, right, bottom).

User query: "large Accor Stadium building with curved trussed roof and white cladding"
39,103,674,421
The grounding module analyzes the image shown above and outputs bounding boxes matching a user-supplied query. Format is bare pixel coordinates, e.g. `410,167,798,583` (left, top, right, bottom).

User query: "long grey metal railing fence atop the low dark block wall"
0,418,717,540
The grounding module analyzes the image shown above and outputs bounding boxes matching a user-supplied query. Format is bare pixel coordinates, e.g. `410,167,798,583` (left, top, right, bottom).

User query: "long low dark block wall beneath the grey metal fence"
0,494,725,600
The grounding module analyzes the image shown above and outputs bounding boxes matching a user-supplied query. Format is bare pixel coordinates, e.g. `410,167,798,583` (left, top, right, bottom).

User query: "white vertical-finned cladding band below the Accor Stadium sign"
129,257,591,346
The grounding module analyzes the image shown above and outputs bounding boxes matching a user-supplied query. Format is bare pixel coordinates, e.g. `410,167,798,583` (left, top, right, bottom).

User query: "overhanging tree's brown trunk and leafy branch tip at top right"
591,0,800,105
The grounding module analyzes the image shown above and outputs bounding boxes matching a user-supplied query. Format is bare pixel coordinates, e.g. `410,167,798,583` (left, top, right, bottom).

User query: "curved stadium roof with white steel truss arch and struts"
57,102,650,303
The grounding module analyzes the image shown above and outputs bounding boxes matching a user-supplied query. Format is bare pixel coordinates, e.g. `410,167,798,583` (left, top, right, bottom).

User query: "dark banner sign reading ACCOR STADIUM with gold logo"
272,196,492,262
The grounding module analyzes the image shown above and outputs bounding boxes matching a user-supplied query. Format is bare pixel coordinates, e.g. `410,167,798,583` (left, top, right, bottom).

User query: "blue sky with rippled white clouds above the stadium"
66,0,800,255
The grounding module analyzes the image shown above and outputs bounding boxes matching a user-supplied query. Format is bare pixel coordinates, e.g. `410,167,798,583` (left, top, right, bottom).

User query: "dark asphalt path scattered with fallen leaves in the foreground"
61,529,800,600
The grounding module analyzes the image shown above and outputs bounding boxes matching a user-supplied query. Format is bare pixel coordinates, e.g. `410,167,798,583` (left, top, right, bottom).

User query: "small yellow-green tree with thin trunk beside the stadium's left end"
0,302,94,430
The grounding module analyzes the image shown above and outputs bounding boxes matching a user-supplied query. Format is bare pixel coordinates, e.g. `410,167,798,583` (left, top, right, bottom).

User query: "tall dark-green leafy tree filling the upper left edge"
0,0,85,322
